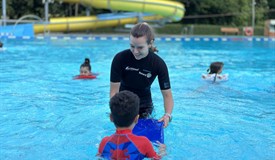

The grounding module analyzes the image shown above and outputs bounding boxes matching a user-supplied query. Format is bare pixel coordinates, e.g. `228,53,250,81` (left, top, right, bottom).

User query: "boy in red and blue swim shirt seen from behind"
97,90,166,160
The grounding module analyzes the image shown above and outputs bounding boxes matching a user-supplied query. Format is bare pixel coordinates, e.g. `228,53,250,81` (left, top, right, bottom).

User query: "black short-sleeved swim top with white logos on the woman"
110,49,170,105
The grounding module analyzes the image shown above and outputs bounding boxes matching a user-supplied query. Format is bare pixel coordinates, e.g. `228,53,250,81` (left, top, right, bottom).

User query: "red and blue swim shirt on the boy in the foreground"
98,129,161,160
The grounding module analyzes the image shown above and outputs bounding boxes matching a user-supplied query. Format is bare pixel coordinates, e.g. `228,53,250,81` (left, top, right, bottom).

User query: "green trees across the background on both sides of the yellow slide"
0,0,275,26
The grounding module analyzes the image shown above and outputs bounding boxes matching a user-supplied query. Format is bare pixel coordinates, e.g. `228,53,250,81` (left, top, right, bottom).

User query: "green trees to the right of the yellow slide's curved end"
178,0,275,26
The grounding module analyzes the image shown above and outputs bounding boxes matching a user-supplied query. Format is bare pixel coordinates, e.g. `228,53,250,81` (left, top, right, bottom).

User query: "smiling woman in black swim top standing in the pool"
110,23,174,127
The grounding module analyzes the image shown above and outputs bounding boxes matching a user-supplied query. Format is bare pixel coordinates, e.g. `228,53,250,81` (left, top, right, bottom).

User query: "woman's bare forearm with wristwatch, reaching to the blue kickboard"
159,89,174,128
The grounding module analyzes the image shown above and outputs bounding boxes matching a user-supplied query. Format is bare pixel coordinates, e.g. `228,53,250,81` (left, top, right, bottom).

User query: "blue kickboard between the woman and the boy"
133,118,164,143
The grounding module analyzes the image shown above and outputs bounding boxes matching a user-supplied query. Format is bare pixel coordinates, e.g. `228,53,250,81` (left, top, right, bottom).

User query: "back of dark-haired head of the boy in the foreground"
109,91,139,127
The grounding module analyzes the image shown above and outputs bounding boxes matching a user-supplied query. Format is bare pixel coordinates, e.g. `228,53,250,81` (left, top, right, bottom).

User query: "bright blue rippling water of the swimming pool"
0,37,275,160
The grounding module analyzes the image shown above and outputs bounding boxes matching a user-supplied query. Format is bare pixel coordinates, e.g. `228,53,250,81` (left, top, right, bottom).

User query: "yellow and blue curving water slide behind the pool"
34,0,185,34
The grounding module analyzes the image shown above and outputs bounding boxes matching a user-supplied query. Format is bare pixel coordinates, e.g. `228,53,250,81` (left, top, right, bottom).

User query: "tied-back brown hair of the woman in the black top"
130,22,158,52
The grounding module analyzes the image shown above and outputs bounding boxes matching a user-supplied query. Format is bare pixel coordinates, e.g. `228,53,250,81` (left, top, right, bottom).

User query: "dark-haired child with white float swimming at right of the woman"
202,62,228,83
